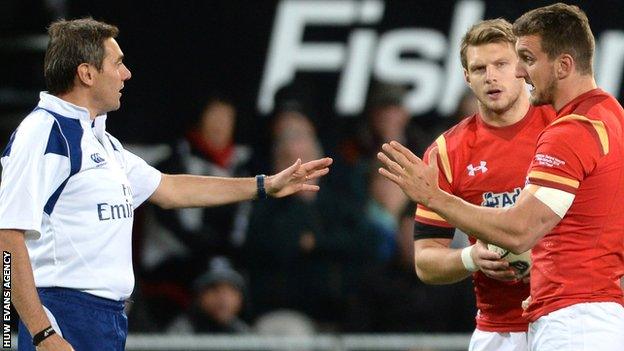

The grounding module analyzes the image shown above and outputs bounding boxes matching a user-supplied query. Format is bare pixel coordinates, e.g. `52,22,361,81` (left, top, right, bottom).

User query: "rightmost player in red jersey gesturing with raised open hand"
378,3,624,351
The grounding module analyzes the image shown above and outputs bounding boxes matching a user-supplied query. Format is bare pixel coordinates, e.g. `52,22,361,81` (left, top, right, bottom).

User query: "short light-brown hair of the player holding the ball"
459,18,516,69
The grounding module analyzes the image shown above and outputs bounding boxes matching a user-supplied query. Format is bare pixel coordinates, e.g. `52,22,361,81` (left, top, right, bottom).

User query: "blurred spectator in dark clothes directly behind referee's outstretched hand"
245,104,376,325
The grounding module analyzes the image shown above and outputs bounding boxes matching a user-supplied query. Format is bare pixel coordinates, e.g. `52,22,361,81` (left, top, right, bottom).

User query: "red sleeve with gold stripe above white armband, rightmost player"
527,115,609,194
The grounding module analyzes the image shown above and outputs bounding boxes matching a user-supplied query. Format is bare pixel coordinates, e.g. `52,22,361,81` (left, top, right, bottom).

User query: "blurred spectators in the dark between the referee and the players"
128,84,476,335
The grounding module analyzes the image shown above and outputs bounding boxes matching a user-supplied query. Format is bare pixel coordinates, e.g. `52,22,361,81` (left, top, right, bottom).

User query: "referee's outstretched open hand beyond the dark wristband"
266,157,334,197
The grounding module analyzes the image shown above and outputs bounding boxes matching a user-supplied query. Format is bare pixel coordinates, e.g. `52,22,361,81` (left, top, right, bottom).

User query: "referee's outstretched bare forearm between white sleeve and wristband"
150,174,268,208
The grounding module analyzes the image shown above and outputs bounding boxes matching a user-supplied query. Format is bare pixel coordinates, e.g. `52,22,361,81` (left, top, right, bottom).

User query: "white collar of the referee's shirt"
38,91,106,140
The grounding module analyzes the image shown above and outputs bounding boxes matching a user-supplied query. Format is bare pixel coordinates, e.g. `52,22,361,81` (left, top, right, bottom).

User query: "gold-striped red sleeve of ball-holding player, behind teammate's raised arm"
414,135,455,239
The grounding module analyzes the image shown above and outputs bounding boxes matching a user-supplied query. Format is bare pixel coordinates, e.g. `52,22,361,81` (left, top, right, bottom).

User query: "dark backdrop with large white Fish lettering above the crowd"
0,0,624,349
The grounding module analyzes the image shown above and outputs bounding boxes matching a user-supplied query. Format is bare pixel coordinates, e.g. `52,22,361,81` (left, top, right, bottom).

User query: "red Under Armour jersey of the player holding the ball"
415,107,555,332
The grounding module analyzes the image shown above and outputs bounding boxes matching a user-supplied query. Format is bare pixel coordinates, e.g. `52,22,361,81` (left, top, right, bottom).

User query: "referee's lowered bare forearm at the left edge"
0,229,50,335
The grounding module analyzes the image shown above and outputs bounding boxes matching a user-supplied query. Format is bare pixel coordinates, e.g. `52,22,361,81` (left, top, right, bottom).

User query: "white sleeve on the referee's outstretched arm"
123,149,162,208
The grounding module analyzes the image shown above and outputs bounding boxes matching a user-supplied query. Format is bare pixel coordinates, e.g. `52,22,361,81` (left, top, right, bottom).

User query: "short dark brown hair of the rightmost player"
513,3,595,74
